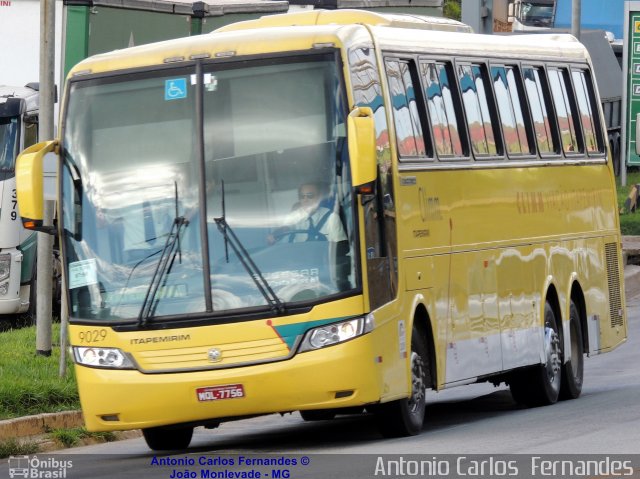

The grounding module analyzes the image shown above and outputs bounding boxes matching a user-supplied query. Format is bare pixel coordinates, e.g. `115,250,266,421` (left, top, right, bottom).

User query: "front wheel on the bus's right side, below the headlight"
375,328,429,437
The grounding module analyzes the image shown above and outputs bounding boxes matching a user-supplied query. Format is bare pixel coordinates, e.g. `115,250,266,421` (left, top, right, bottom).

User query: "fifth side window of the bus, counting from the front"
522,67,560,155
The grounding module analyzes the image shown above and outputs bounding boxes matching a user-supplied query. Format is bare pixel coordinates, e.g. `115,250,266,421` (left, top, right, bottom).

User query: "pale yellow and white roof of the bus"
70,10,588,79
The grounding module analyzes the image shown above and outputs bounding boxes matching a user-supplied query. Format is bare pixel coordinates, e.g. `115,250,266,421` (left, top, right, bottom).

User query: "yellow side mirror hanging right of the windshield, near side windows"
347,106,378,187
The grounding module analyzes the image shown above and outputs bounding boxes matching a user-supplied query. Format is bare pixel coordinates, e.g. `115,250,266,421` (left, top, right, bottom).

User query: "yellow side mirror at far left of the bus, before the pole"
16,141,58,234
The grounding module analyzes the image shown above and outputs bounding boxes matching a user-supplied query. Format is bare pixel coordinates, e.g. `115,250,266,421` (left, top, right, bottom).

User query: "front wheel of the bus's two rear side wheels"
509,302,562,407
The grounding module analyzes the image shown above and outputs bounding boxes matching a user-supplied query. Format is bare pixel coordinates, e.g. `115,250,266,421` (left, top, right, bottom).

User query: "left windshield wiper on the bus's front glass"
138,216,189,326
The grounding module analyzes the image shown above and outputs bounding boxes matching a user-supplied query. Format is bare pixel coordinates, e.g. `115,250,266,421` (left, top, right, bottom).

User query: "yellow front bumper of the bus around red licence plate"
76,335,381,431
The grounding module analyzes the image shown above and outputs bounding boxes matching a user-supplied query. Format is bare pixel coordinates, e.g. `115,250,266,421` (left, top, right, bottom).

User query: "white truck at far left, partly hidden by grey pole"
0,0,63,320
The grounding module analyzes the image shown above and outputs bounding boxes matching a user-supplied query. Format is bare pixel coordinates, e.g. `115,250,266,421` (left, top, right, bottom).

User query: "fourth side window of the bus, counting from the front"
491,66,531,154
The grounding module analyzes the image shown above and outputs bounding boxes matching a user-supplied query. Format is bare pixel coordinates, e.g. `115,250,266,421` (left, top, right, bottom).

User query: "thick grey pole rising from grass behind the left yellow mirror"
36,0,56,356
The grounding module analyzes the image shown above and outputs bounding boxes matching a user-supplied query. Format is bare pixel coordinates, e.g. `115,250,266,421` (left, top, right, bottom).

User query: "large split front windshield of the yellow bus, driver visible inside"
62,53,359,322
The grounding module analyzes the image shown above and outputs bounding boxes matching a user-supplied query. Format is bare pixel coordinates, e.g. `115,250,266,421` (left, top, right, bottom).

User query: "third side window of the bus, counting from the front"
458,65,498,155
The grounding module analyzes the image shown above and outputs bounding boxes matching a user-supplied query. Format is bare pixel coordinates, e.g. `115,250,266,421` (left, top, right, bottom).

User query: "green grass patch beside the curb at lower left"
0,324,80,420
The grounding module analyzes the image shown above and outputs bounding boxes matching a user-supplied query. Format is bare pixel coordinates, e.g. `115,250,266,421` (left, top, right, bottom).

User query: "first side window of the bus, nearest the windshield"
386,60,427,159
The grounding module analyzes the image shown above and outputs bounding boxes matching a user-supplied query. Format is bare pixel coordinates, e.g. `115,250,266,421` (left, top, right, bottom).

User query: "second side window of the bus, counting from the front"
420,63,463,156
